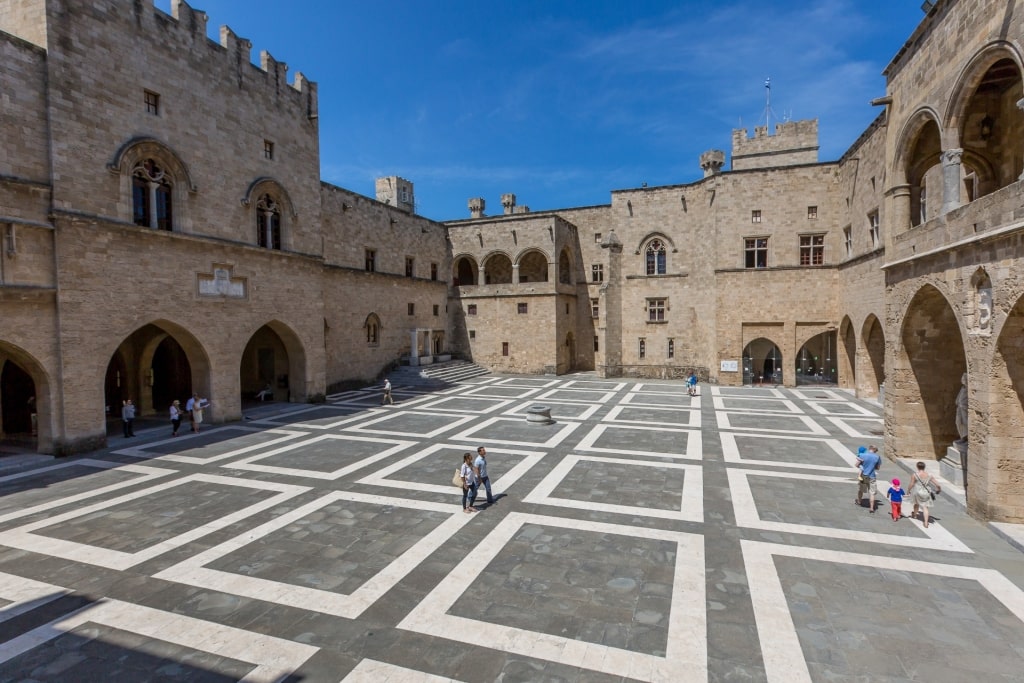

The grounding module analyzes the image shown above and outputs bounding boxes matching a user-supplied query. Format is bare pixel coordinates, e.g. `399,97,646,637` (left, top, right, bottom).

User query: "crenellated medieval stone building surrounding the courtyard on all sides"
0,0,1024,521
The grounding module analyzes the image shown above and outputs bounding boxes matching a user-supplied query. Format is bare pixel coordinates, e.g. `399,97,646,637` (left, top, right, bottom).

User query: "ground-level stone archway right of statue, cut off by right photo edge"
987,295,1024,522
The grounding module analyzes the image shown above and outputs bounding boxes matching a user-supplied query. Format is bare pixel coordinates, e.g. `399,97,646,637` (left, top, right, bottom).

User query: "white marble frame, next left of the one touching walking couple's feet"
0,474,309,569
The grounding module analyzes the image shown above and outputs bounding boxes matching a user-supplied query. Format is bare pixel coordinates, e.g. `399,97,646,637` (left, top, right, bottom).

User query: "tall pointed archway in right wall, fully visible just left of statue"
886,285,967,459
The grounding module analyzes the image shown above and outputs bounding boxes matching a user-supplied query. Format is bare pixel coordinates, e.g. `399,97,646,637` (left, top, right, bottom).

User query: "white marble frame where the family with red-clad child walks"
726,469,974,553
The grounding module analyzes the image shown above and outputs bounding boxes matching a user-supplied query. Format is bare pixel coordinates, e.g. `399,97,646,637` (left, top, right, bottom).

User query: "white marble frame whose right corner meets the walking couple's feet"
155,492,472,618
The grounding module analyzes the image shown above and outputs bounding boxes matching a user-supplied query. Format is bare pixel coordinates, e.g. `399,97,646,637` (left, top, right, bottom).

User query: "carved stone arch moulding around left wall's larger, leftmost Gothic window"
106,137,198,232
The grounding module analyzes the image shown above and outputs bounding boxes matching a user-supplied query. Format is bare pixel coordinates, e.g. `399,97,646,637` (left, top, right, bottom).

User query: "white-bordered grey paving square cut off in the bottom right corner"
740,541,1024,683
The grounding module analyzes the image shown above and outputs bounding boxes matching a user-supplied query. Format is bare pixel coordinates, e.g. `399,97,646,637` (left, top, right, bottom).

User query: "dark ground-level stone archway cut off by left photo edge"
0,341,58,453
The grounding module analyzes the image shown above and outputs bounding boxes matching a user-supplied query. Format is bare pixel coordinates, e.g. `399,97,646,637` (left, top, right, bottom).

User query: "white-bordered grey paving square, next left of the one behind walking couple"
221,434,416,480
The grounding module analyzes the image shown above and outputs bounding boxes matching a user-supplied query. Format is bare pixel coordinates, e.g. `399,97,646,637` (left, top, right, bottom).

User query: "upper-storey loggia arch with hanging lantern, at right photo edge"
944,40,1024,201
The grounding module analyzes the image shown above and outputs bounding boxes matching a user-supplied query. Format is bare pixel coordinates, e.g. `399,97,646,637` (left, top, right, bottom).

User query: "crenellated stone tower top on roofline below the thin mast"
732,119,818,171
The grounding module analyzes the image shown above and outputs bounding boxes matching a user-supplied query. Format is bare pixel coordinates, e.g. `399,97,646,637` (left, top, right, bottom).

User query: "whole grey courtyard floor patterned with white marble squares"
0,375,1024,683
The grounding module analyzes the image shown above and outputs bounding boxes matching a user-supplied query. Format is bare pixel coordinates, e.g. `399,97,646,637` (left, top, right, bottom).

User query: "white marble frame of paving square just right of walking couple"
523,456,703,522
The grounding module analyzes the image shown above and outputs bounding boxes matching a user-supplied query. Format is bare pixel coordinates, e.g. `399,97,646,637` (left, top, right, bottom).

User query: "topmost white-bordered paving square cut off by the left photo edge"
0,458,177,522
